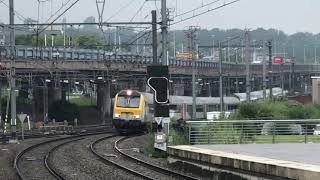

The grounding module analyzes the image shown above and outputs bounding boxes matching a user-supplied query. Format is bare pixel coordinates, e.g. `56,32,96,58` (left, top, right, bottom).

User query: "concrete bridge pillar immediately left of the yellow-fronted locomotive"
97,81,111,124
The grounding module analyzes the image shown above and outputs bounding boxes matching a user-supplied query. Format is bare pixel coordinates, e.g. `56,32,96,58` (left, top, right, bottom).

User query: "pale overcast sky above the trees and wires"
0,0,320,34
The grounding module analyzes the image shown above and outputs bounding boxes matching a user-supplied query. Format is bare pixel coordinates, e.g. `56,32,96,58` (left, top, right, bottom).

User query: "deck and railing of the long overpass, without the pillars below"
0,46,320,95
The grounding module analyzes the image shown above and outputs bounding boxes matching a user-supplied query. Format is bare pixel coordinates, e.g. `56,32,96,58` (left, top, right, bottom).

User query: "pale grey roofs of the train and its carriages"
142,93,240,105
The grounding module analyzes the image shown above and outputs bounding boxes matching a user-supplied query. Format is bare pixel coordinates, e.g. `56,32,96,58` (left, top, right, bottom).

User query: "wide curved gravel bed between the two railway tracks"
52,135,144,180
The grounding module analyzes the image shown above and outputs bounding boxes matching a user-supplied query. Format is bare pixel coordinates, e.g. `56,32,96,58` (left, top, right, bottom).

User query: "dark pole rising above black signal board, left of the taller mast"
152,10,159,64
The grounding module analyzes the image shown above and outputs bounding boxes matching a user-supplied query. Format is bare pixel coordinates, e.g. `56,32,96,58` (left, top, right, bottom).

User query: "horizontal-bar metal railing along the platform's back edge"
187,119,320,144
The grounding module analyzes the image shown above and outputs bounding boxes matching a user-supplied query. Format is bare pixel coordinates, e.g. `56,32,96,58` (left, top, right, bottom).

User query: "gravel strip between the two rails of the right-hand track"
96,137,181,180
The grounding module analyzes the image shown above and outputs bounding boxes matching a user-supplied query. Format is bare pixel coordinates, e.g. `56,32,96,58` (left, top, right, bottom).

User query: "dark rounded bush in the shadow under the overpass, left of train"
49,100,80,122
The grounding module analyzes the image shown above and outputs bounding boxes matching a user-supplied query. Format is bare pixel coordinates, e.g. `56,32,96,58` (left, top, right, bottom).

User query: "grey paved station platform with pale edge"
168,144,320,180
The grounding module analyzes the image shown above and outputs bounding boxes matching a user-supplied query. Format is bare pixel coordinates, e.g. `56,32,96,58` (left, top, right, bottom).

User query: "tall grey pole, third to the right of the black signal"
245,30,251,102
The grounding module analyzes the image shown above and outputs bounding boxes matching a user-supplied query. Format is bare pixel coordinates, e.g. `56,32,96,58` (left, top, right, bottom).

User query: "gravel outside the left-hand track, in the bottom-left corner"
0,138,65,180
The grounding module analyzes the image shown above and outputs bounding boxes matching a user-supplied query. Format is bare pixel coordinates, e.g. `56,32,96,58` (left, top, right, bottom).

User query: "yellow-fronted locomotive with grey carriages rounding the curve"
112,90,240,133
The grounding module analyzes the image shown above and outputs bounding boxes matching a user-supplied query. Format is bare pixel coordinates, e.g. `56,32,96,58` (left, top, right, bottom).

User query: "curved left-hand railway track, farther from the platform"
14,132,110,180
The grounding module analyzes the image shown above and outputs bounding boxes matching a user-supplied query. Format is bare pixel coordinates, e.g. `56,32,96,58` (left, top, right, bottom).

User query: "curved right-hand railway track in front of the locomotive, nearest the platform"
90,136,197,180
